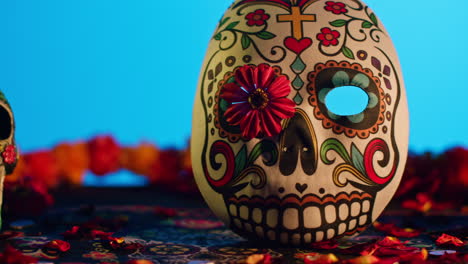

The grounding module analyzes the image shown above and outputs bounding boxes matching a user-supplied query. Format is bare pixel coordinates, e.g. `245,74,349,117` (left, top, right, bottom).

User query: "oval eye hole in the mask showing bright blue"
322,86,369,116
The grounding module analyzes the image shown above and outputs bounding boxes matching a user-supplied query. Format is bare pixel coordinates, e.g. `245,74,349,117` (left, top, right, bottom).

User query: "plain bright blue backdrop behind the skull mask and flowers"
0,0,468,184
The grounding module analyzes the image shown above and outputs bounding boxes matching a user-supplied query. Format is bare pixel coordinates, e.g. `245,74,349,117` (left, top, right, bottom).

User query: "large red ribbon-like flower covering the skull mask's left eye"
221,64,295,139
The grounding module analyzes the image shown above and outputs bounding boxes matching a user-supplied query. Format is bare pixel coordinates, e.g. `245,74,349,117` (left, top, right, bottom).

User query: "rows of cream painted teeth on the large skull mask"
228,194,373,245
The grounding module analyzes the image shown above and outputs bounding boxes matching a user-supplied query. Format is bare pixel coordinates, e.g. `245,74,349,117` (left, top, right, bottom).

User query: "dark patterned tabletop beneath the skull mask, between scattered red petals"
0,188,468,264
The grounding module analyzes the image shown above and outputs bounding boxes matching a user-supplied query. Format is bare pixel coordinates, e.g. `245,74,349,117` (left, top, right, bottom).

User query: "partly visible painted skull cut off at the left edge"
0,91,18,227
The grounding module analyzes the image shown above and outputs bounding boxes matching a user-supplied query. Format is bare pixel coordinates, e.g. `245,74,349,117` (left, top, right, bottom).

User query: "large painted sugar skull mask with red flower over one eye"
191,0,408,245
